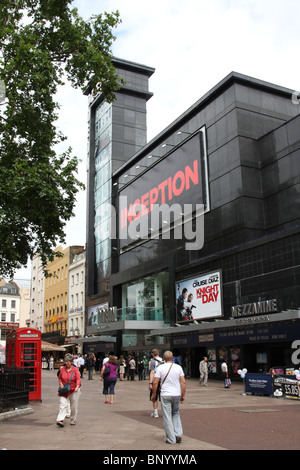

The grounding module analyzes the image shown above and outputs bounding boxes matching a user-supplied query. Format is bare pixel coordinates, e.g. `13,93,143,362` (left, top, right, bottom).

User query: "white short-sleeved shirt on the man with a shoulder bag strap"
155,362,184,397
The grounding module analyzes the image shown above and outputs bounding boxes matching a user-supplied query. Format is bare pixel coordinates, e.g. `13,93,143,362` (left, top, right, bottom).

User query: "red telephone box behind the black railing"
6,328,42,401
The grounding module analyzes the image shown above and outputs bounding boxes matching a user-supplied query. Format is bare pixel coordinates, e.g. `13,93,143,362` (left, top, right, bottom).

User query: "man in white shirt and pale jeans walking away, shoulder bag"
152,351,186,444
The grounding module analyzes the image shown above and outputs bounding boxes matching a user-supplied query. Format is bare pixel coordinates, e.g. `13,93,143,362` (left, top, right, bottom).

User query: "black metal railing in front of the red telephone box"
0,365,30,412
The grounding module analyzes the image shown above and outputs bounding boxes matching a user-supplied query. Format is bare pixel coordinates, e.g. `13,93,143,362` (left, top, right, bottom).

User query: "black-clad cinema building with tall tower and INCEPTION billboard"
85,59,300,376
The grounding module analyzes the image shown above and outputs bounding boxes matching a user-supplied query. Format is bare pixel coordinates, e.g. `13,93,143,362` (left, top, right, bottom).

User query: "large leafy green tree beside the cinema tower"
0,0,121,276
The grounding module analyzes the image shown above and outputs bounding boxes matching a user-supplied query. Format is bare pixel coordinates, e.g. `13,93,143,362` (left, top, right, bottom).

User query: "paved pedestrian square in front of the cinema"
0,370,300,456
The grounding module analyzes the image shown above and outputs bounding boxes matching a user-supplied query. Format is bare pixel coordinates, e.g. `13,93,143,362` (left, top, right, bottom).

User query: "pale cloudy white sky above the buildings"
15,0,300,279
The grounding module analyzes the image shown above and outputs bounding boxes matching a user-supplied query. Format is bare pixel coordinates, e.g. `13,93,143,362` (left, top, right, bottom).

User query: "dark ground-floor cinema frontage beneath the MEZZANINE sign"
152,310,300,379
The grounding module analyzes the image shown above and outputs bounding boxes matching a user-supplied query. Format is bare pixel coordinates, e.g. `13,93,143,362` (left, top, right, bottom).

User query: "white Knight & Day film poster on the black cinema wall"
176,270,223,323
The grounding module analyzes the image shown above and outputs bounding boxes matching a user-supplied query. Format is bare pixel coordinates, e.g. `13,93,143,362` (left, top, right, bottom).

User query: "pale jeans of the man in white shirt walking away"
161,396,182,444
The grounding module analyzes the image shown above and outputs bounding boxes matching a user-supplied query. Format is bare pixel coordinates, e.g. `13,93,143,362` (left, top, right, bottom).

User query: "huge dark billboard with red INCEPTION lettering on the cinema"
118,128,209,250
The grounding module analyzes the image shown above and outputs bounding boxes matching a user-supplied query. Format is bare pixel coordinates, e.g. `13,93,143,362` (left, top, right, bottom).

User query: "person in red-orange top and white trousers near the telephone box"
56,354,80,428
